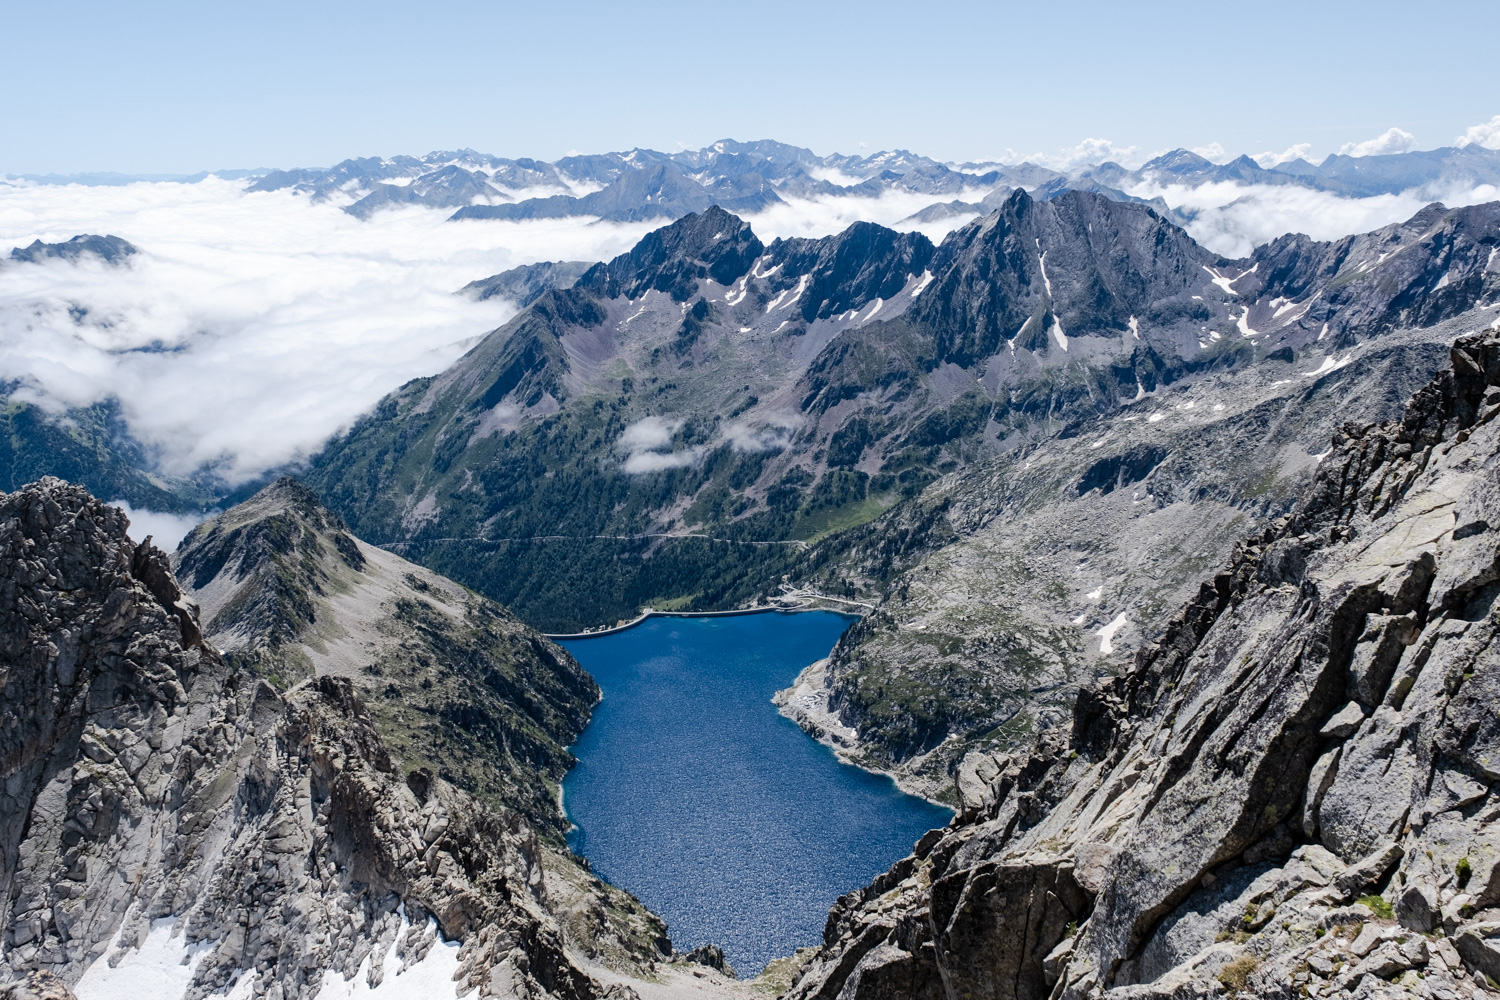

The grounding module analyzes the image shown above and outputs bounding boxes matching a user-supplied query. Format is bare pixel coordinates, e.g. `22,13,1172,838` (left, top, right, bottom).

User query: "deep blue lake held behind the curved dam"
563,612,951,976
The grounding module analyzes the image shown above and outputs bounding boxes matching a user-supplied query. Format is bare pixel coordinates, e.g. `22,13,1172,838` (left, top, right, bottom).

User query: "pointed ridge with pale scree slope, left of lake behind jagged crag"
173,478,600,843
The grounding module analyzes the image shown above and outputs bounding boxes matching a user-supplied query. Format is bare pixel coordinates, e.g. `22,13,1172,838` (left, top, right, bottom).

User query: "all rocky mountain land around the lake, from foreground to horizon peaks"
0,141,1500,1000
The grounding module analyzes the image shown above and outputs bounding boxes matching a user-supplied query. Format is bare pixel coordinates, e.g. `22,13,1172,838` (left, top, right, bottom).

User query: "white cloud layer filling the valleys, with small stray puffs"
0,131,1500,539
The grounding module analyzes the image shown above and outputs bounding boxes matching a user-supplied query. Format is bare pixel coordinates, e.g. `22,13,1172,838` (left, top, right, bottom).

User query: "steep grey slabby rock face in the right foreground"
789,331,1500,1000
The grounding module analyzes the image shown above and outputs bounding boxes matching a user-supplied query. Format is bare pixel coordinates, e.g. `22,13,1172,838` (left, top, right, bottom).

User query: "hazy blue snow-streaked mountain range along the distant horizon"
11,139,1500,225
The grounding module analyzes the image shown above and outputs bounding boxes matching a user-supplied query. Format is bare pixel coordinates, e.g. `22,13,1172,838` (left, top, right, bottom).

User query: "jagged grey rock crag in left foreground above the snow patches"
0,480,657,1000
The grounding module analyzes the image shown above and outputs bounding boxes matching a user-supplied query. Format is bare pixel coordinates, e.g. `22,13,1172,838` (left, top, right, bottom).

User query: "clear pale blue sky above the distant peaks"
0,0,1500,172
